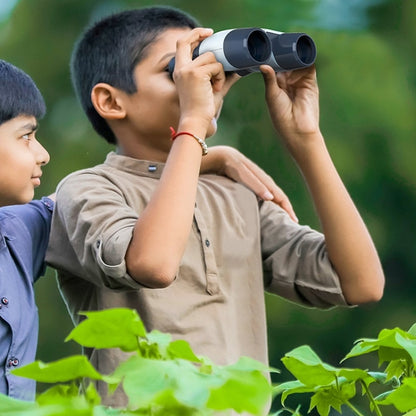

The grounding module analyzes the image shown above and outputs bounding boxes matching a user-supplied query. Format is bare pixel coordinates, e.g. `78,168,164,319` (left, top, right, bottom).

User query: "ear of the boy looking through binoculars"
91,82,126,120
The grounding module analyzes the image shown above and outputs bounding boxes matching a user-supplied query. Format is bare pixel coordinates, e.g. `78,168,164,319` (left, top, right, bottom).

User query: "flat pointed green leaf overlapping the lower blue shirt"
13,355,105,383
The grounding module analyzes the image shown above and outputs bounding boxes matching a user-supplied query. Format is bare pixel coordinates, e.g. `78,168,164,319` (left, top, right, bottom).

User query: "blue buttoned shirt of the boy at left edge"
0,198,53,400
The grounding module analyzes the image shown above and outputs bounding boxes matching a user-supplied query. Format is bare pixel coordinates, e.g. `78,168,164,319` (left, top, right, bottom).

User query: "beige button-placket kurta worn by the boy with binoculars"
47,153,346,406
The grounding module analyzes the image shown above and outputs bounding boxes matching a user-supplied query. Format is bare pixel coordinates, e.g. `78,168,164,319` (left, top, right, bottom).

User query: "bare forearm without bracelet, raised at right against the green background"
293,133,384,304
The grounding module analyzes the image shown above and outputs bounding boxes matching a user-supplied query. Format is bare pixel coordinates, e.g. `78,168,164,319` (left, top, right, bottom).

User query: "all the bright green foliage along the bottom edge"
4,308,416,416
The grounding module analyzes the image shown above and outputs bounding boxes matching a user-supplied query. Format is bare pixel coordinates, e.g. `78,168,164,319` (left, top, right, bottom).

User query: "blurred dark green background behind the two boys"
0,0,416,414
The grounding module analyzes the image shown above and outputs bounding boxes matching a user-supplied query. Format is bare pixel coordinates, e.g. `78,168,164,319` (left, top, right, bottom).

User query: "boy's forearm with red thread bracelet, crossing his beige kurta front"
126,128,206,287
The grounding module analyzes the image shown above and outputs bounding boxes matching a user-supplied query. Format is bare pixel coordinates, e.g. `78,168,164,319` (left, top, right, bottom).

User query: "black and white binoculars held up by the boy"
168,27,316,76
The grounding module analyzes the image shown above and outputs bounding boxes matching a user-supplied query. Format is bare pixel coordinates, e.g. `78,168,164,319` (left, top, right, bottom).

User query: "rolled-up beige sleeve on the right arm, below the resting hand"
260,202,347,308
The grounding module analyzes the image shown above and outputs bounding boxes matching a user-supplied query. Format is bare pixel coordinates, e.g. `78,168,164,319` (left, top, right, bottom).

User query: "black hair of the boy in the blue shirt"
0,59,46,124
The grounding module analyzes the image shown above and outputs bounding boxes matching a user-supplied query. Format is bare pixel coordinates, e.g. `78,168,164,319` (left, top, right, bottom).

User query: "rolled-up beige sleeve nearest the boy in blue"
46,171,142,290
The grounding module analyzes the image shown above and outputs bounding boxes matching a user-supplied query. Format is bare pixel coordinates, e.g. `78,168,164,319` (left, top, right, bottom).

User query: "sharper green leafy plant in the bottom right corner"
274,324,416,416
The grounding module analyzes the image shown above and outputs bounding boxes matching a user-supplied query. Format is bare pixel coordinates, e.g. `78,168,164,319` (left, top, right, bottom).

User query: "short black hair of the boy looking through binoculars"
71,6,199,144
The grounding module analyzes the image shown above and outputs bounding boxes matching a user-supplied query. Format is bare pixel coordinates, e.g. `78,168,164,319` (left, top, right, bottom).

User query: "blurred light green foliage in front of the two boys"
0,308,272,416
